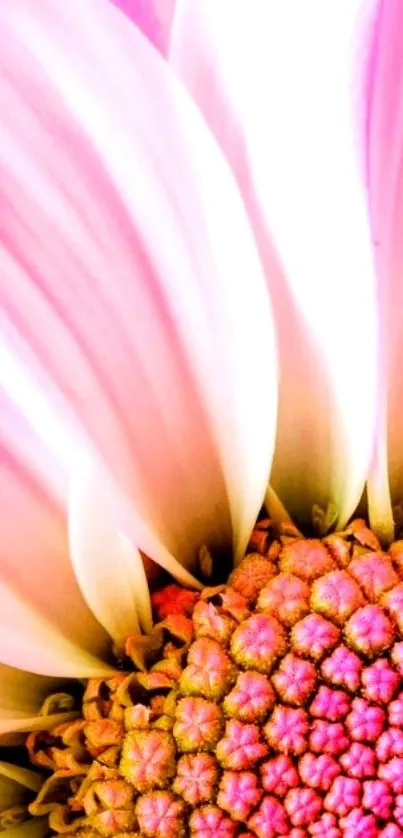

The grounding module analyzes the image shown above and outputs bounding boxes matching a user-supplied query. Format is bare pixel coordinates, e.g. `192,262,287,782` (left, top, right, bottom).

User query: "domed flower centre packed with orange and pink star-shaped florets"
16,521,403,838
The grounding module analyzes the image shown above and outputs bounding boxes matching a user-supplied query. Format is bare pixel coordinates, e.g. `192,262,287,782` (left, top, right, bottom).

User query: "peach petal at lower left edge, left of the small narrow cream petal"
0,426,108,676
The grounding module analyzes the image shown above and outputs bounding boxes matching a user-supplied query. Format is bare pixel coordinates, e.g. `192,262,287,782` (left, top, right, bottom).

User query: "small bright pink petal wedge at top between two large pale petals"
112,0,176,54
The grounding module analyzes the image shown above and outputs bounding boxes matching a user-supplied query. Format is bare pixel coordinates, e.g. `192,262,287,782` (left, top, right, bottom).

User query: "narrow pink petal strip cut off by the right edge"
362,0,403,540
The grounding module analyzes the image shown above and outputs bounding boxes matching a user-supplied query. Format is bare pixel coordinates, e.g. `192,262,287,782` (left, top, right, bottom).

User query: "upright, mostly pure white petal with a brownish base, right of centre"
170,0,377,528
